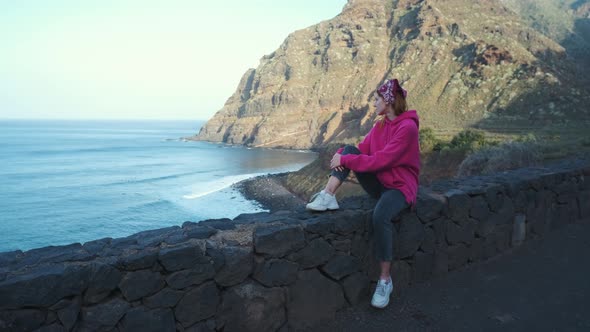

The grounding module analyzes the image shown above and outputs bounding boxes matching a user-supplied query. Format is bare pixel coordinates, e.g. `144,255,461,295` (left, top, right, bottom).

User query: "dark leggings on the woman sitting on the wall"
331,145,409,262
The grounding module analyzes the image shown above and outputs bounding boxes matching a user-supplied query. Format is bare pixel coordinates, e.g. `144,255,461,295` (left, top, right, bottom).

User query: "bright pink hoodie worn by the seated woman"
339,110,420,205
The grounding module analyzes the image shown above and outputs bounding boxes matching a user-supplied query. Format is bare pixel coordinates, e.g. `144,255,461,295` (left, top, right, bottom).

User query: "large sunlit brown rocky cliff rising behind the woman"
195,0,590,148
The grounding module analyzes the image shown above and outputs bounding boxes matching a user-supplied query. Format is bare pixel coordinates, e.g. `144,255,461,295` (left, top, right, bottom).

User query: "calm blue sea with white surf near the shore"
0,121,316,252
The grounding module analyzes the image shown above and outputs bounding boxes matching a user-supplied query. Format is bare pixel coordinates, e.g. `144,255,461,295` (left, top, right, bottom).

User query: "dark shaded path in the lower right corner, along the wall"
316,223,590,332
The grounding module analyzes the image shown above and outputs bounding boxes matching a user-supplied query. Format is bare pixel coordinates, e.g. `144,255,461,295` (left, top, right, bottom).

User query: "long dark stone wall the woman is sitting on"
0,161,590,331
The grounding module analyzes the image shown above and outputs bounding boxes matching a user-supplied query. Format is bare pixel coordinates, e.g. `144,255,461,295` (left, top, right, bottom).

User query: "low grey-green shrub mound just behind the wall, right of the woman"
457,141,542,176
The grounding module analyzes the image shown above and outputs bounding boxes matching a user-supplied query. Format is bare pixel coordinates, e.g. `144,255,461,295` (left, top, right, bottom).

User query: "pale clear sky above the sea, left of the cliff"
0,0,347,120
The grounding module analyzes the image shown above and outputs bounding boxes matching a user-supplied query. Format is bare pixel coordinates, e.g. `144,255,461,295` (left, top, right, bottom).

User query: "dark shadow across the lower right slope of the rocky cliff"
472,45,590,144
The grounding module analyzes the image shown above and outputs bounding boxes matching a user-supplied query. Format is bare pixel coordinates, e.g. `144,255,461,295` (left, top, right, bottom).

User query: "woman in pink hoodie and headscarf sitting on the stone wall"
306,79,420,308
